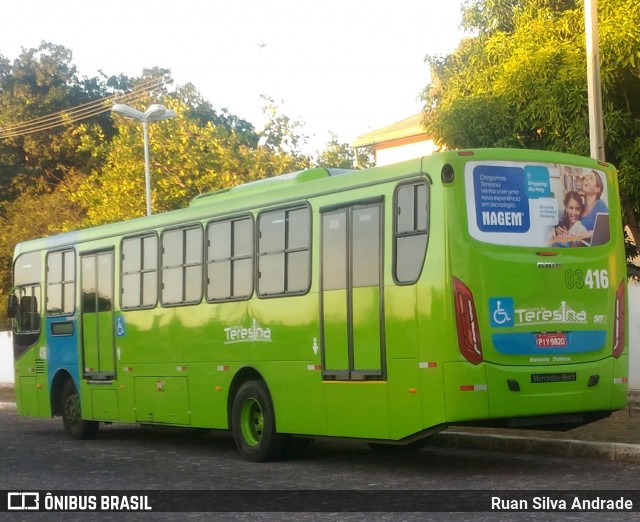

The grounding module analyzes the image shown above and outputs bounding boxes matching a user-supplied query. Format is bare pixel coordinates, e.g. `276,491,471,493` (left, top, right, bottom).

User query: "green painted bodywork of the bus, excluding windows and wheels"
10,150,628,440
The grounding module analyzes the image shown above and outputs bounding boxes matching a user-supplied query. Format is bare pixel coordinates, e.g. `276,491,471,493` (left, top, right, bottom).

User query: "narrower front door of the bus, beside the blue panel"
80,250,116,380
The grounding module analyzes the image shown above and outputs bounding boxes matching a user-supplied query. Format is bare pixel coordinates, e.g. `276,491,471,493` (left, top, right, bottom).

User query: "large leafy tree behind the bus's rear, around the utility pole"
423,0,640,254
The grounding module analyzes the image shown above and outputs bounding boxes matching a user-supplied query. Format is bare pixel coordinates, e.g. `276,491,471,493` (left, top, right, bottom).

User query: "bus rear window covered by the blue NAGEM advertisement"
465,162,610,248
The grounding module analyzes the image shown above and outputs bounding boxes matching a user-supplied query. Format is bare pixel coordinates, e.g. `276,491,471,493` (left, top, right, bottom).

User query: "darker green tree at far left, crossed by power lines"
0,42,110,201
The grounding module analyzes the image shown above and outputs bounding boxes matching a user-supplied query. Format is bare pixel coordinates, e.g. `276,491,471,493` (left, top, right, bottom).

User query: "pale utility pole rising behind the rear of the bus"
584,0,605,161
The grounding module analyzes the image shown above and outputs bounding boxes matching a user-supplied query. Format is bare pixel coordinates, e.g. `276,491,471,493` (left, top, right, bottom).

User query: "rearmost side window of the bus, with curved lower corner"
393,181,429,285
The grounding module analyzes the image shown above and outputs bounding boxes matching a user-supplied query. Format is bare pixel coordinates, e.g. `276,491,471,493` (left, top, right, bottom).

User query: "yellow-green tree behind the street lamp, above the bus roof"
72,94,309,226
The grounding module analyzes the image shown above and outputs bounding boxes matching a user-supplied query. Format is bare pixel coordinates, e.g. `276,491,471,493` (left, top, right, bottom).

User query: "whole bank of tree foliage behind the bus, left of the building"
0,42,370,314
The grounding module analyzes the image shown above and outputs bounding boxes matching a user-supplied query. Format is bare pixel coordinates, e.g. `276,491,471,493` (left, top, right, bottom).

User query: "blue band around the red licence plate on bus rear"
491,330,607,356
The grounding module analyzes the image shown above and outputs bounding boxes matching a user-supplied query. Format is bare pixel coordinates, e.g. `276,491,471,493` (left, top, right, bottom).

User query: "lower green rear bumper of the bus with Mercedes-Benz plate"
444,355,628,424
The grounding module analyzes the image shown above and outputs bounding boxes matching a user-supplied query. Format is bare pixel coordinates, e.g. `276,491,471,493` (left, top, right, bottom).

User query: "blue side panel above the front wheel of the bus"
45,316,80,389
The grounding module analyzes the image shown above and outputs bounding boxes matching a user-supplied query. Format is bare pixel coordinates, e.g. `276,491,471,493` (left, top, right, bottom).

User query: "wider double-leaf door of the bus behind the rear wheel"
320,200,385,381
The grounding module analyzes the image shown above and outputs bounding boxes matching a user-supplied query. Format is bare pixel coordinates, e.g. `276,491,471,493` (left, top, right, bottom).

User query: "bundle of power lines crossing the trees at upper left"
0,77,169,138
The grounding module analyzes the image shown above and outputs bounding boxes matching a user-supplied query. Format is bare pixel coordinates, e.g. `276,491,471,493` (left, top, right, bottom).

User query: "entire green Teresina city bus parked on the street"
8,149,628,461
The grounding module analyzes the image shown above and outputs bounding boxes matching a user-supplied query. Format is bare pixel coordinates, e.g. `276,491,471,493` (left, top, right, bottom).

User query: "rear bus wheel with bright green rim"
231,381,288,462
